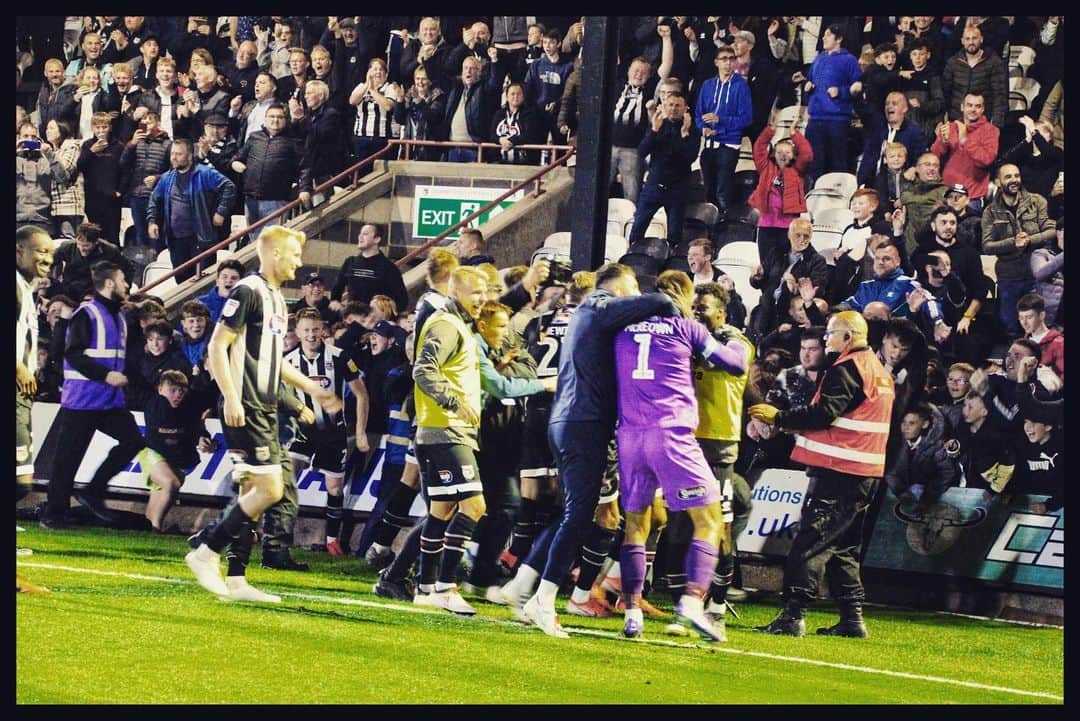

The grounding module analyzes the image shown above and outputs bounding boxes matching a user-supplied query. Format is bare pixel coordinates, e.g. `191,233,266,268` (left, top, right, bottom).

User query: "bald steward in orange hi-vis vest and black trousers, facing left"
750,311,895,638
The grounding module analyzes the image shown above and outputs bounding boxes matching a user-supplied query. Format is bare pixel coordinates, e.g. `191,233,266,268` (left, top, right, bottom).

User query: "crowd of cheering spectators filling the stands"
16,16,1065,582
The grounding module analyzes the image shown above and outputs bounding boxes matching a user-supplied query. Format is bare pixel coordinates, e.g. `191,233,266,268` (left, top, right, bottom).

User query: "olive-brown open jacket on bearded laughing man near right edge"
983,190,1057,281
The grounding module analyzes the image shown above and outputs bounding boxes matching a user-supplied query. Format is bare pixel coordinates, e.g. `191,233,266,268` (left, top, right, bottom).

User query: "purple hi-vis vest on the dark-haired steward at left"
60,298,127,410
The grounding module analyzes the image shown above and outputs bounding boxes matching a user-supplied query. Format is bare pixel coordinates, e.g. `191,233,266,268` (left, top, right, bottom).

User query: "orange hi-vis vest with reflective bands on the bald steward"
792,348,896,478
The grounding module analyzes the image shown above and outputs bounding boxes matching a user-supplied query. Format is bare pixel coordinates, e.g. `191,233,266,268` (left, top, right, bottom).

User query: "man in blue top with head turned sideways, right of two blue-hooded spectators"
805,25,863,181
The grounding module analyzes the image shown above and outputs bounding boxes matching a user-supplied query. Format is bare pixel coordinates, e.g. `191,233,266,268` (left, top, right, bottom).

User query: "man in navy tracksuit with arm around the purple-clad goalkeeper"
518,263,679,638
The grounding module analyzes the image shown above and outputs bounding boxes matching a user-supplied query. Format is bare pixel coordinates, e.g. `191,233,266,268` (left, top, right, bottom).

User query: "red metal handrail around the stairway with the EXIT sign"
139,138,573,293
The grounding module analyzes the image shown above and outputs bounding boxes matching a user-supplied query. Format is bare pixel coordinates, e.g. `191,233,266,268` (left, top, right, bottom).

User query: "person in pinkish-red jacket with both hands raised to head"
750,125,813,264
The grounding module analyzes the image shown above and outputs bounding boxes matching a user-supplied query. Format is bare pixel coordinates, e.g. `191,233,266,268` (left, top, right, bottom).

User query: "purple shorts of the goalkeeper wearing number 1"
616,427,720,513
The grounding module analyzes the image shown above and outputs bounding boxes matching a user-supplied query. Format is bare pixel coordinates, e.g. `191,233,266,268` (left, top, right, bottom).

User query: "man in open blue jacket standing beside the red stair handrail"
146,138,237,283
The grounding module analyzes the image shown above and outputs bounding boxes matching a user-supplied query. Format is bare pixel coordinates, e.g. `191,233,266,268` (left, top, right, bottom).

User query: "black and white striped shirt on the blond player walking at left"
218,273,288,413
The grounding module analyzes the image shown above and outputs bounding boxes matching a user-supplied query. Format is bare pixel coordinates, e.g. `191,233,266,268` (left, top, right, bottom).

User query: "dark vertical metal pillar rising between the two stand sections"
570,16,619,270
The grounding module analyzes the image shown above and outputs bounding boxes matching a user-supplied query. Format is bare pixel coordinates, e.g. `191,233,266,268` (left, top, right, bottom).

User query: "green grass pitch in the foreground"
16,528,1064,704
